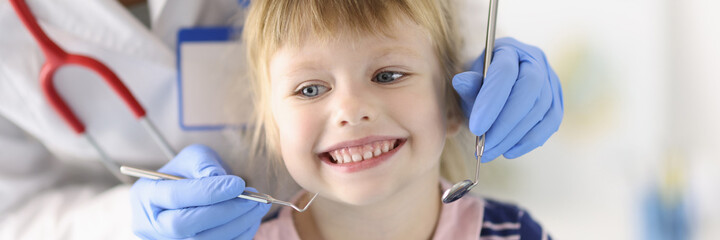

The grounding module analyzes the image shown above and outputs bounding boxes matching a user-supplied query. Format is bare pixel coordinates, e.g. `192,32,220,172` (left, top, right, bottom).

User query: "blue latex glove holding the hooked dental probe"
130,145,270,239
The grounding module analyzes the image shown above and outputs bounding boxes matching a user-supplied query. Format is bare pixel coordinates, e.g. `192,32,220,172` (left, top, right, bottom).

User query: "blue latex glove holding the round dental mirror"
453,38,563,162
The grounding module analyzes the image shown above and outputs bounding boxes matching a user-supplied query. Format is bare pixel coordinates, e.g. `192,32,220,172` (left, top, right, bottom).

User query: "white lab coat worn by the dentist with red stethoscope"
0,0,486,239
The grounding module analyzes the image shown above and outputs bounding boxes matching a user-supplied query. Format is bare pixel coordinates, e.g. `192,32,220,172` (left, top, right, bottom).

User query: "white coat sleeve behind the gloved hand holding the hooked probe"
0,116,135,239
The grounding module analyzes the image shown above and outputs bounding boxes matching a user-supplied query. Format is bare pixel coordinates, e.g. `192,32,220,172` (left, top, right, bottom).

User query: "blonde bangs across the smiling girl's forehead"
243,0,459,80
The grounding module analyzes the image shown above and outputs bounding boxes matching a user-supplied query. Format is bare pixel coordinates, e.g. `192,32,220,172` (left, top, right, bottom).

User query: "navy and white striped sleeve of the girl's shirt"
480,199,552,240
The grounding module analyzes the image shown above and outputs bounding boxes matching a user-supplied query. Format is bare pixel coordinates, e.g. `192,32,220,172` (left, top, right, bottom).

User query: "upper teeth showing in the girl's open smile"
329,139,397,163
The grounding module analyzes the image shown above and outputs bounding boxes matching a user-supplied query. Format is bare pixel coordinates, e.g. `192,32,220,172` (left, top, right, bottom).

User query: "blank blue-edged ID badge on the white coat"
176,27,252,131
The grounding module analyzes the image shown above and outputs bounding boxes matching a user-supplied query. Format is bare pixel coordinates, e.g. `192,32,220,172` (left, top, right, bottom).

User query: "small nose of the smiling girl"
333,90,377,127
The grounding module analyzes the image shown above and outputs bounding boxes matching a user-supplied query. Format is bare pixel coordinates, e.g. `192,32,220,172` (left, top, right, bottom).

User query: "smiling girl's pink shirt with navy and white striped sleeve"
255,181,552,240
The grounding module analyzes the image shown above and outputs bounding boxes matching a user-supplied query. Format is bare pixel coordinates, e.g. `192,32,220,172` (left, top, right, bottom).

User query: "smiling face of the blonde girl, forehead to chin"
269,21,456,205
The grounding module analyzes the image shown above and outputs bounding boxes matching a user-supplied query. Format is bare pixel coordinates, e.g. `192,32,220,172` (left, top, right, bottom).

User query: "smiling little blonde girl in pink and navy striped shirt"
243,0,549,239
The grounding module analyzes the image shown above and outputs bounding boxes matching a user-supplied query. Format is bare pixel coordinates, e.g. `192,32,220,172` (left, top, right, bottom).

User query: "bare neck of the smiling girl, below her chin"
293,171,441,239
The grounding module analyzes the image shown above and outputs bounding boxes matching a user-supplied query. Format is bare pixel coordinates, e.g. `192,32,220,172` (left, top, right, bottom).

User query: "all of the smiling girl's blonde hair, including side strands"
243,0,466,181
